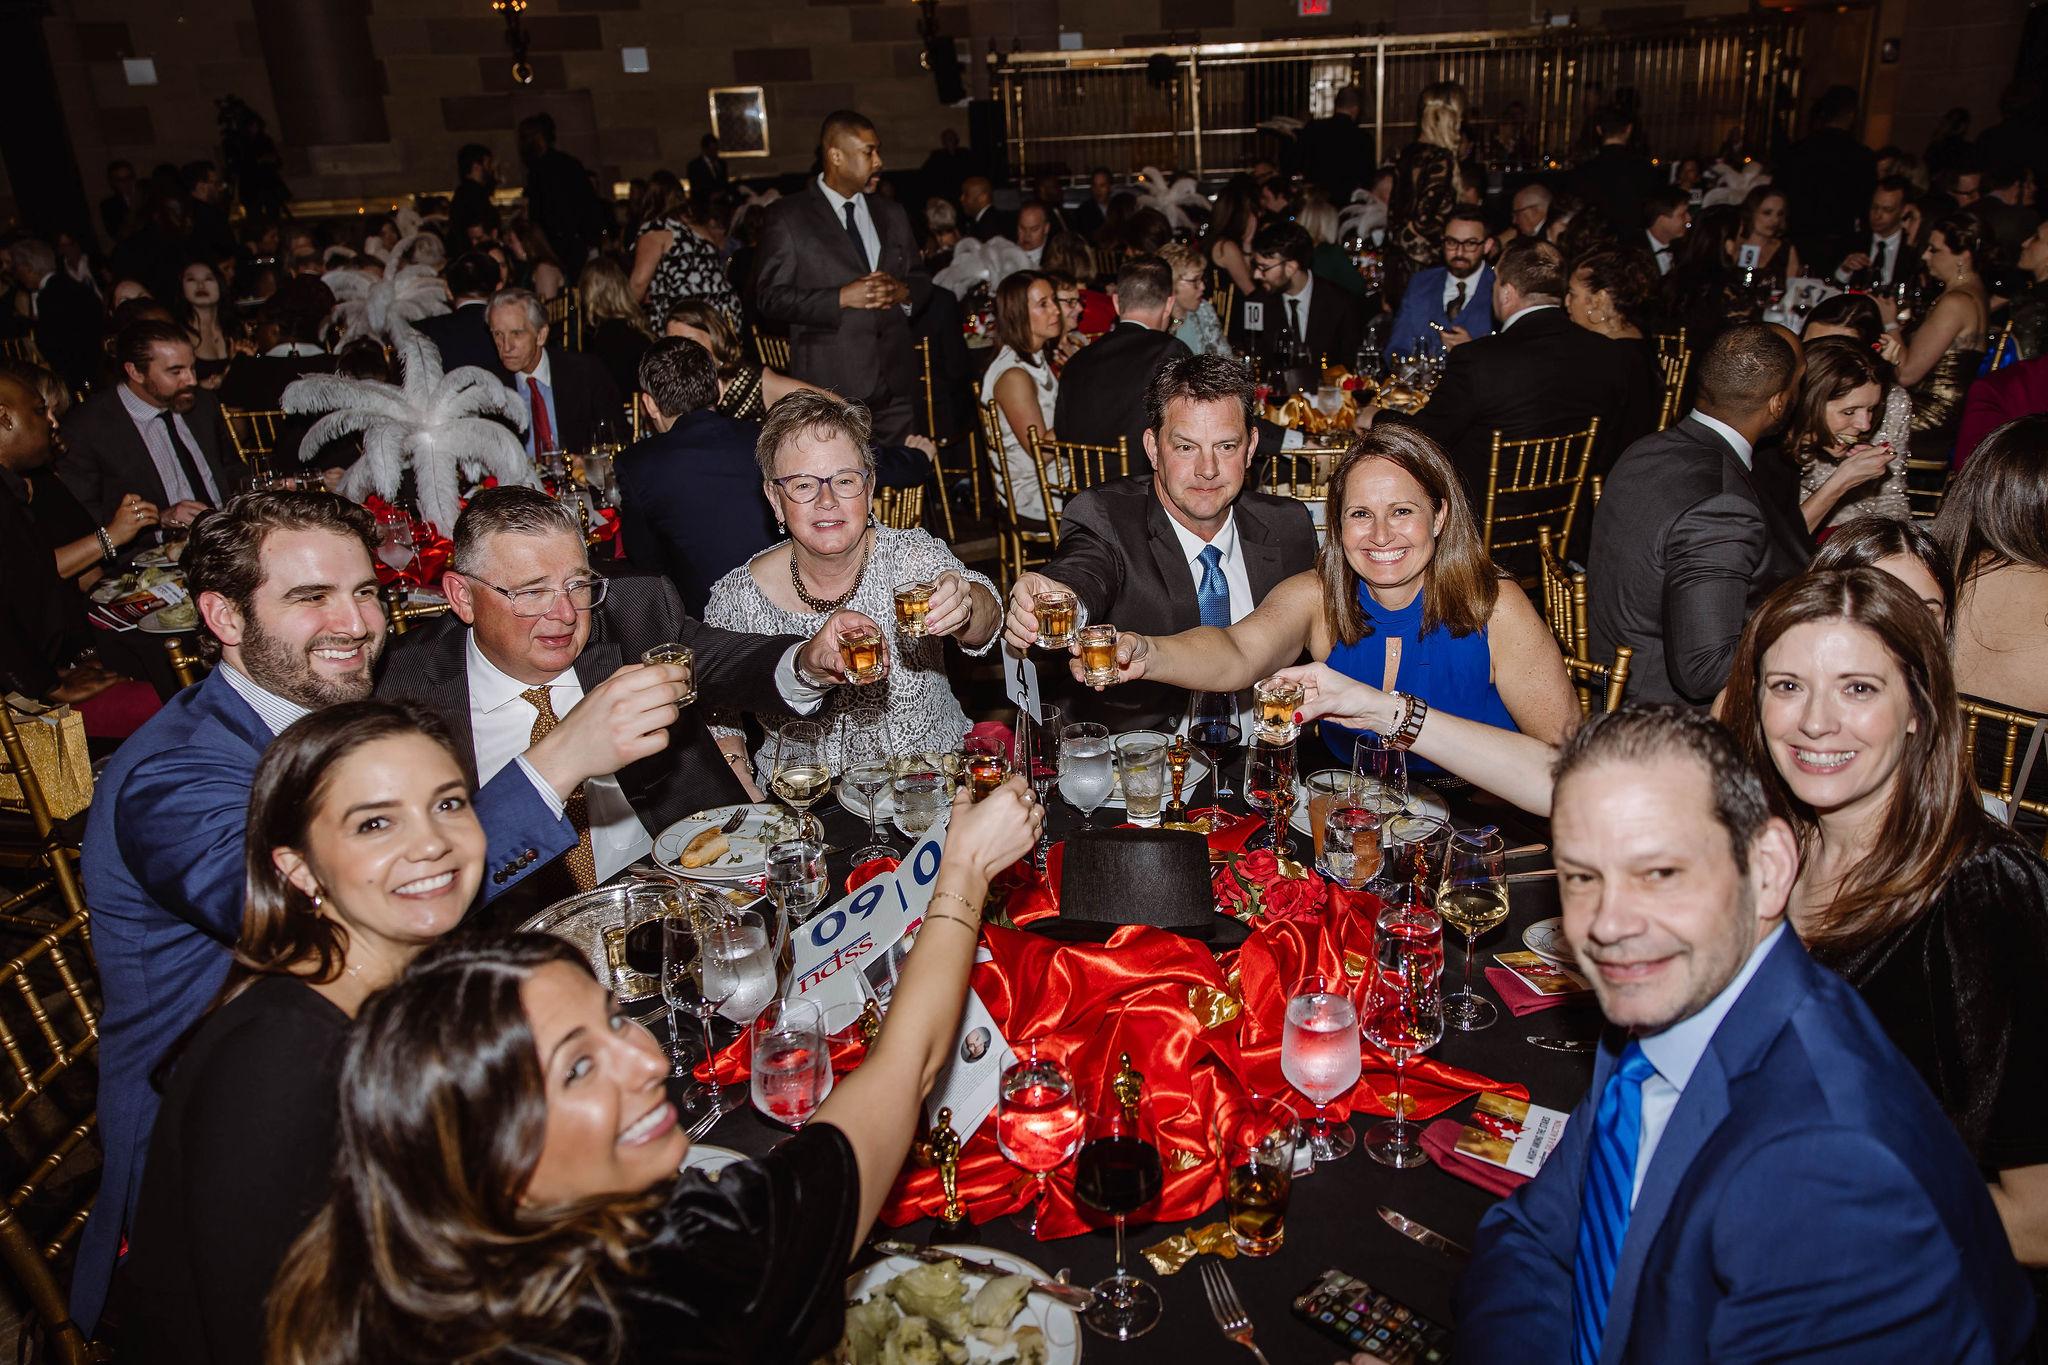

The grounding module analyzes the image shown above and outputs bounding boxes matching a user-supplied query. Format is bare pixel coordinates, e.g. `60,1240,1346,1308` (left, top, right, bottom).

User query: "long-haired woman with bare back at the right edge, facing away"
1933,413,2048,712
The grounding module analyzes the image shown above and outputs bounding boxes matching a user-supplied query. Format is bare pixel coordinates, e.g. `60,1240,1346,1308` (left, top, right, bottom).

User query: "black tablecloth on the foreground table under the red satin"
671,753,1599,1365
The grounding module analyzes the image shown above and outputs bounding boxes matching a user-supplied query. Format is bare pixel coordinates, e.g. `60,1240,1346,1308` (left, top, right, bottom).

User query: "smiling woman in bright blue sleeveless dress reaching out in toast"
1118,424,1579,812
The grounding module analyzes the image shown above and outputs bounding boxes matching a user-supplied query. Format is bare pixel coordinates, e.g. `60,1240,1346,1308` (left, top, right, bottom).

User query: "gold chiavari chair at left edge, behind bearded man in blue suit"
0,708,111,1365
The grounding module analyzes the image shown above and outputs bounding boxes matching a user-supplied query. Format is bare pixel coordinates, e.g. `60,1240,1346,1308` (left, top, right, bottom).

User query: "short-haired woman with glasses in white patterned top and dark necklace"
705,391,1001,786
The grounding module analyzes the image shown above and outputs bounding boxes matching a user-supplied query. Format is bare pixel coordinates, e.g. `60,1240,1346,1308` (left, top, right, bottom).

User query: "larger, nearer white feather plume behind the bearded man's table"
283,333,537,534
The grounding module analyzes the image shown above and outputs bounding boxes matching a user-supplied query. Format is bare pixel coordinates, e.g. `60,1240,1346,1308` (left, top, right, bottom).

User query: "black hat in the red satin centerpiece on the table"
1030,829,1251,948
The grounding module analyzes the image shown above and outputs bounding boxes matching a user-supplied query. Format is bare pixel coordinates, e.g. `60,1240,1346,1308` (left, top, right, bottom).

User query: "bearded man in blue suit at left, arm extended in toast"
72,493,684,1334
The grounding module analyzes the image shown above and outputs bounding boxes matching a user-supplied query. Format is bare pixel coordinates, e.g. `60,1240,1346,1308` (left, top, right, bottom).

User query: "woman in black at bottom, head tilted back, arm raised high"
268,778,1042,1365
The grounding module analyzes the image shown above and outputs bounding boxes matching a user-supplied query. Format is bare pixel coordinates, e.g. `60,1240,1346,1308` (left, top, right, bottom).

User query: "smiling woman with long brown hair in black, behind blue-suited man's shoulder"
1724,569,2048,1293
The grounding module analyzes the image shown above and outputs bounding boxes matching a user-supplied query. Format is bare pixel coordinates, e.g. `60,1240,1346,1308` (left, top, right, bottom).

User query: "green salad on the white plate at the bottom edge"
836,1261,1047,1365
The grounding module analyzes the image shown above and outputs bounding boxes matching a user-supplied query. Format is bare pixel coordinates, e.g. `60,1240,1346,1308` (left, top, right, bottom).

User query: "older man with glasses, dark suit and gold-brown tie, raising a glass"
377,487,868,925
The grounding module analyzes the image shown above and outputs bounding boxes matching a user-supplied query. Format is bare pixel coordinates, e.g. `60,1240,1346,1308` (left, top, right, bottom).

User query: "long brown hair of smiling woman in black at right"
1724,569,1991,964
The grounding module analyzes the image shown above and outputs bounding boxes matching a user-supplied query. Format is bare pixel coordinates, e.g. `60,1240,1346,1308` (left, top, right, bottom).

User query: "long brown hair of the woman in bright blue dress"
1317,424,1501,645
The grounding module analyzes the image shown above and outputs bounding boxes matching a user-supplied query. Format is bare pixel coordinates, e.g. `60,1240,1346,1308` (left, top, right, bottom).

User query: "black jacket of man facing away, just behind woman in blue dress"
1380,309,1655,499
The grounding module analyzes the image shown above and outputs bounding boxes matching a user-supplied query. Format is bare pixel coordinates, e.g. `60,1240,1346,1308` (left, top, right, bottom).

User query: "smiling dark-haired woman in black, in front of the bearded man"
118,702,485,1365
